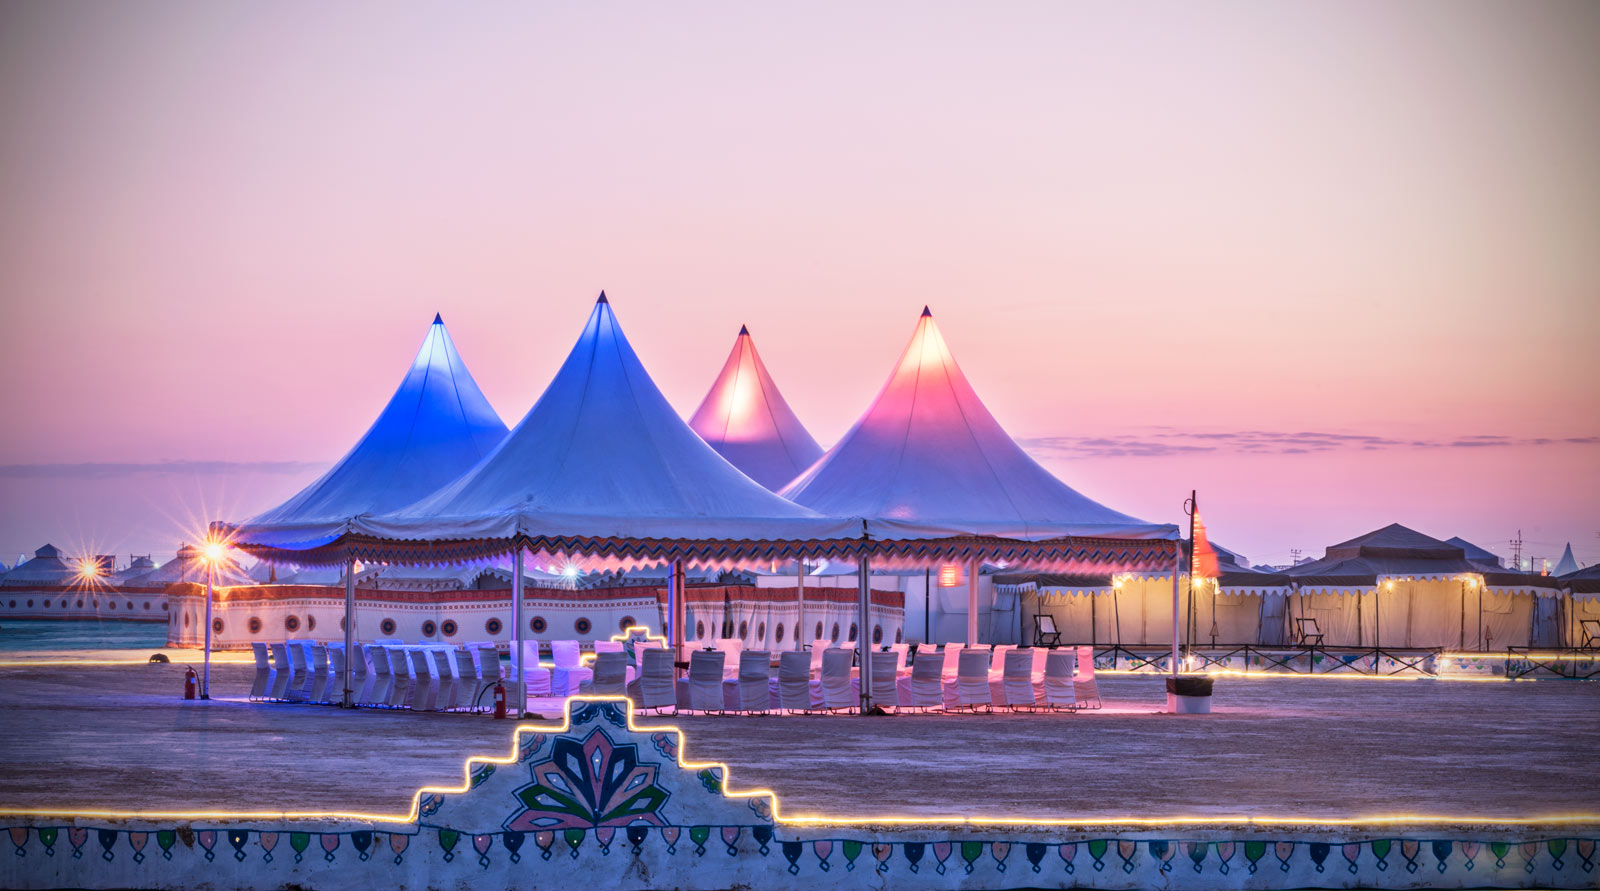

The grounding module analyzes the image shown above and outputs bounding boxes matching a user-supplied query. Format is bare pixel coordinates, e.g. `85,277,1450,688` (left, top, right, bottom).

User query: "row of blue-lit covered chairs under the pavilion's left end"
250,640,502,712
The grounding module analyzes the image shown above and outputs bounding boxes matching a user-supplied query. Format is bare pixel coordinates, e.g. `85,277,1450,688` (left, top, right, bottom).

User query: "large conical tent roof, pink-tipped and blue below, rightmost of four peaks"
782,309,1174,541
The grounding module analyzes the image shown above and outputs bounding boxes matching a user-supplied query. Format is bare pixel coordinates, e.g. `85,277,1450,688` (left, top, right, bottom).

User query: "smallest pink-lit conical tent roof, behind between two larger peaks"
690,326,822,491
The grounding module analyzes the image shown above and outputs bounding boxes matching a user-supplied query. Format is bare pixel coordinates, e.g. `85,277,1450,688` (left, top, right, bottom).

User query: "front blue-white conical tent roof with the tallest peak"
355,294,861,561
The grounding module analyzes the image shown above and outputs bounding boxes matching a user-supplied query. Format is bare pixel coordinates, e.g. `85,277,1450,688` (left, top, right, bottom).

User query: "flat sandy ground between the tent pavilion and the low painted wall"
0,664,1600,817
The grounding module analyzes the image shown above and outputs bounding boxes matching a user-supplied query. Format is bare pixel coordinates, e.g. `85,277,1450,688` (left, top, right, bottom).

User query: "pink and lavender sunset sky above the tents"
0,0,1600,563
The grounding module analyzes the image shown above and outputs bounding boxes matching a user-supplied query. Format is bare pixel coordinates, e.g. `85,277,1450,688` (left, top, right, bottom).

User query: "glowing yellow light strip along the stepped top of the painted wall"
0,696,1600,829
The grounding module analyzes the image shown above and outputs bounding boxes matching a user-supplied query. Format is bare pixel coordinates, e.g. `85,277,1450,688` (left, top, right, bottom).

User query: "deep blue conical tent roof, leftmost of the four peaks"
234,315,506,547
